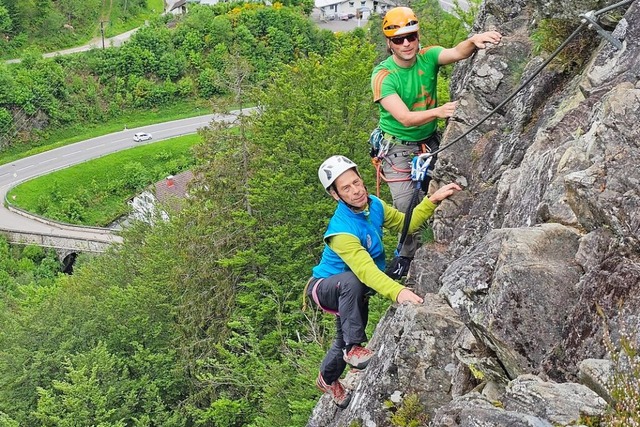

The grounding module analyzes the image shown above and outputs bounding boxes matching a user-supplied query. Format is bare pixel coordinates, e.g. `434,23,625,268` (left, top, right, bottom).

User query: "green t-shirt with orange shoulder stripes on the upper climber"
371,46,444,141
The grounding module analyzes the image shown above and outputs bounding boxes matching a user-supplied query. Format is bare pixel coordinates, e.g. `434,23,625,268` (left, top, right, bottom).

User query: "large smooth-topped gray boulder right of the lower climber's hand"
440,224,582,378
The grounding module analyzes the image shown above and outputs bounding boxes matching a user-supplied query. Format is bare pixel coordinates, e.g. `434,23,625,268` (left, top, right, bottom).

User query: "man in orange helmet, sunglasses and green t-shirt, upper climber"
371,7,502,268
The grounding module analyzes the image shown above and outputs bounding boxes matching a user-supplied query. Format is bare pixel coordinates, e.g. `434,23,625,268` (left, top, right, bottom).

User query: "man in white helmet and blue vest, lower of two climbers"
305,156,461,408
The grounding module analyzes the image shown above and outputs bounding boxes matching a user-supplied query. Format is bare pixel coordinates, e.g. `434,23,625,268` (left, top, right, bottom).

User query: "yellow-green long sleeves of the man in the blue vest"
327,197,436,301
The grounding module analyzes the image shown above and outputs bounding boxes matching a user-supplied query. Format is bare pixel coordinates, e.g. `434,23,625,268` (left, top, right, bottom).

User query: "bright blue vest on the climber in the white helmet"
312,196,385,279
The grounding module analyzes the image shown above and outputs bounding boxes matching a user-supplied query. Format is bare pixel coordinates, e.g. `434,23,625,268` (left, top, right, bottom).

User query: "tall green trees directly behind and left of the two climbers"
182,34,376,427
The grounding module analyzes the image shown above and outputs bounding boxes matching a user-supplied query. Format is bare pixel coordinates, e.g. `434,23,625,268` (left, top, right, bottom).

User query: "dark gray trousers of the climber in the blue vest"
307,271,372,384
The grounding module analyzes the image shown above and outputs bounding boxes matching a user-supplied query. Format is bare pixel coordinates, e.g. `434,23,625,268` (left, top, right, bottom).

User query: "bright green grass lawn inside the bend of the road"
7,134,202,227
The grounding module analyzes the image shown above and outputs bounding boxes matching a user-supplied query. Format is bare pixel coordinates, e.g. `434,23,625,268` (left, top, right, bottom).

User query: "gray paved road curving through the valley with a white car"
0,110,240,242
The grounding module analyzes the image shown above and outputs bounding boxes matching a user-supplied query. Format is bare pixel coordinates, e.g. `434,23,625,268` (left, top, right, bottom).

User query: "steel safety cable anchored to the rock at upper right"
374,0,635,181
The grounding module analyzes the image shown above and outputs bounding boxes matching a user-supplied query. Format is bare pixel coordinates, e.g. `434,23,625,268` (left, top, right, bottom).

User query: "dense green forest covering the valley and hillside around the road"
0,2,476,427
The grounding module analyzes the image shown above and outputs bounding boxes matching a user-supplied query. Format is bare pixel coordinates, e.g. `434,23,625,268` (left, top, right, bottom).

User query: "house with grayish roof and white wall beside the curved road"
129,171,193,224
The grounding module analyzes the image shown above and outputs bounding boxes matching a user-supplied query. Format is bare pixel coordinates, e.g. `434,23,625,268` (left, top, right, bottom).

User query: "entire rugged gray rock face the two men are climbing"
309,0,640,427
